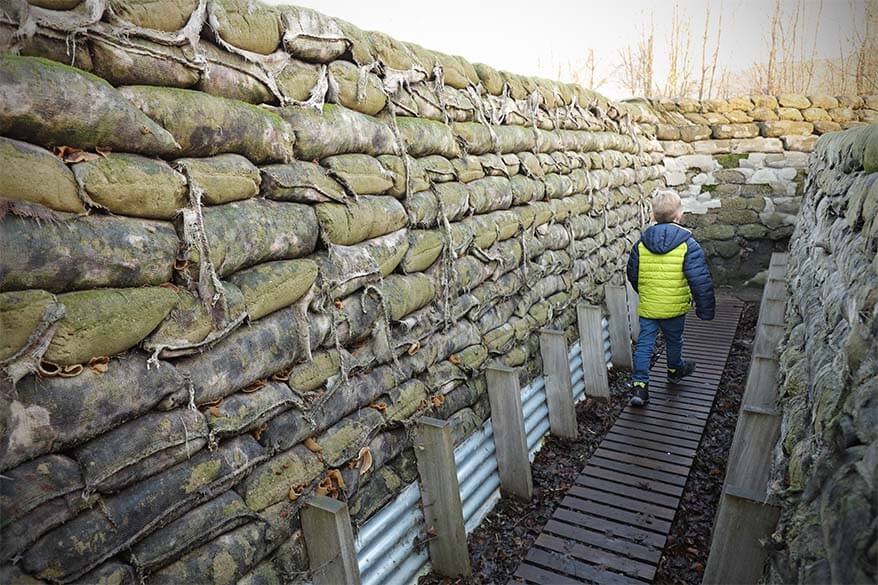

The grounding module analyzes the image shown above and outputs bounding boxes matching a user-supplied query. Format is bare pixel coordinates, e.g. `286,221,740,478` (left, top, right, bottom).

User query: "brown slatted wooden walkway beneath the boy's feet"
512,297,743,585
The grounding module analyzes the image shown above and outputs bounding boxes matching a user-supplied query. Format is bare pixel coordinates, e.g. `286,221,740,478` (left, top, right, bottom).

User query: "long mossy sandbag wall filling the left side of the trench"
0,0,661,584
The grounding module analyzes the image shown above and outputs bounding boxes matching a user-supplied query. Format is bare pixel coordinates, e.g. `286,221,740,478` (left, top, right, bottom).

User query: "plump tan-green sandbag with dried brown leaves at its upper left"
73,153,189,220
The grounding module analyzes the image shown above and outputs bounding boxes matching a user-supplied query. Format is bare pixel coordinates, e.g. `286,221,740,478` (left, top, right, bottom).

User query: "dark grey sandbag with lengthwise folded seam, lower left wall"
74,408,208,493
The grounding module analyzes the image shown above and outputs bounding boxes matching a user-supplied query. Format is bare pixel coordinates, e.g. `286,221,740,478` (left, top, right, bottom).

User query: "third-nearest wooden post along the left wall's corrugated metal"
486,366,533,501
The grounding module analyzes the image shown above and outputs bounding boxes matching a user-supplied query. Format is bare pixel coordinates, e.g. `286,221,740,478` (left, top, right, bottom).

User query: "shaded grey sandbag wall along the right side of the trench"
767,125,878,583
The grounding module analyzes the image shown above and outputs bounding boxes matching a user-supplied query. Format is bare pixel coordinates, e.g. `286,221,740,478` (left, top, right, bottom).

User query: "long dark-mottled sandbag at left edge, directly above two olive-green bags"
0,215,179,292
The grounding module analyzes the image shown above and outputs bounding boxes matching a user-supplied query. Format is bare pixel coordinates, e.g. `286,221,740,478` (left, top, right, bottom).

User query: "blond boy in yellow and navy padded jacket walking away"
628,191,716,406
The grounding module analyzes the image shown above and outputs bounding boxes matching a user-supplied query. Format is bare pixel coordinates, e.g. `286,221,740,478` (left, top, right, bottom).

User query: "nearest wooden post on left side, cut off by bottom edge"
301,496,360,585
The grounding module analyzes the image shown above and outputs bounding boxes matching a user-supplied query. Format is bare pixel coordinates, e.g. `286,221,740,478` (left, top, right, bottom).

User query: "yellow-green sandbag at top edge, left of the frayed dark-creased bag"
207,0,283,55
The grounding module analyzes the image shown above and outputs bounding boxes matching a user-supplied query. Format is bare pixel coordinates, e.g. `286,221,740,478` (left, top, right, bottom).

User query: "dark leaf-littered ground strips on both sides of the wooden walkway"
418,302,759,585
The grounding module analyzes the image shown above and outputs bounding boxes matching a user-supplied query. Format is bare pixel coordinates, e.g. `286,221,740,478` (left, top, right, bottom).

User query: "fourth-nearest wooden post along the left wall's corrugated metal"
540,329,578,440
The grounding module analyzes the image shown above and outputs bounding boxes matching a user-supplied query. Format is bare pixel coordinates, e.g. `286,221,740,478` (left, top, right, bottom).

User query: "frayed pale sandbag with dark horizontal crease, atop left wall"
281,6,351,63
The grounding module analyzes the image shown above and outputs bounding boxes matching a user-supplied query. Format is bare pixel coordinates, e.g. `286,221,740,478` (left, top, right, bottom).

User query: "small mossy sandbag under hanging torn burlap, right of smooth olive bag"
141,282,247,358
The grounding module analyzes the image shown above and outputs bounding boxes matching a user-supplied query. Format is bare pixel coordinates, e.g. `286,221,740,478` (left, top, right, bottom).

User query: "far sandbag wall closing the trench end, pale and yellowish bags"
638,94,878,285
